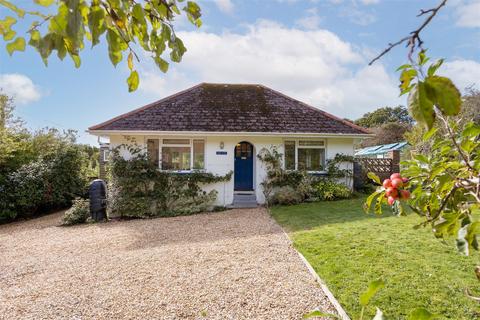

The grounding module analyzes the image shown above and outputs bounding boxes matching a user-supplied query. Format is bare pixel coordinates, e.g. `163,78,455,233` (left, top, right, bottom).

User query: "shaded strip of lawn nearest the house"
271,198,395,232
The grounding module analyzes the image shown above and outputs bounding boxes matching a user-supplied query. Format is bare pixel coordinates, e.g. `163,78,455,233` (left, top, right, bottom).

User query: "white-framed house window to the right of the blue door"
285,140,325,171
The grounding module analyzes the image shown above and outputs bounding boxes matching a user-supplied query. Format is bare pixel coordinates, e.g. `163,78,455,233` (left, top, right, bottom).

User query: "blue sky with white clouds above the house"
0,0,480,144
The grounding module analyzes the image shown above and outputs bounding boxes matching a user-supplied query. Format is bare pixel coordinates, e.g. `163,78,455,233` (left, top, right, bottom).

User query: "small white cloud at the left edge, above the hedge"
0,73,41,104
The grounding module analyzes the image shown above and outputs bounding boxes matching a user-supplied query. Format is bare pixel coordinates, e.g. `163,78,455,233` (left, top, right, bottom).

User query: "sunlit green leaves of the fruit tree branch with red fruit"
366,52,480,254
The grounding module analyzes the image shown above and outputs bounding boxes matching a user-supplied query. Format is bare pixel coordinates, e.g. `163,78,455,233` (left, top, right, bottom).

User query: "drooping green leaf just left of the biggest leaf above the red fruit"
407,81,435,129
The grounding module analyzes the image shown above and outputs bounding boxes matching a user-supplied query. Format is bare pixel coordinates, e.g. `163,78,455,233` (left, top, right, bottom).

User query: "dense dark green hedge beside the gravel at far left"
0,95,97,221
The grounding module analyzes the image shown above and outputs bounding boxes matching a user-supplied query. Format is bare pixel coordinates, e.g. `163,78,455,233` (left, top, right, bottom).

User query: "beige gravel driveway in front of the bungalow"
0,208,333,319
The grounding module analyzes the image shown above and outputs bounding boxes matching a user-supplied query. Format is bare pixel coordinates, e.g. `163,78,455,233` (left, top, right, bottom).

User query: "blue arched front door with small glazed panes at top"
234,142,253,191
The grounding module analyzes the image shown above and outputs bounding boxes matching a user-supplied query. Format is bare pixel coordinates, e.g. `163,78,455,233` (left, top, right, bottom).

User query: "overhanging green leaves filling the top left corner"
0,0,201,91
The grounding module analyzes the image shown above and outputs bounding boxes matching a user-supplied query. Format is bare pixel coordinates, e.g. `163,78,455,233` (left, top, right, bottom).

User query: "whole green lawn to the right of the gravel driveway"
271,199,480,320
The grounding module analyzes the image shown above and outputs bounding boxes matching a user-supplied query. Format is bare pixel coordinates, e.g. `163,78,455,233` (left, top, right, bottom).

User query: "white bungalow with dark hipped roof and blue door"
88,83,370,205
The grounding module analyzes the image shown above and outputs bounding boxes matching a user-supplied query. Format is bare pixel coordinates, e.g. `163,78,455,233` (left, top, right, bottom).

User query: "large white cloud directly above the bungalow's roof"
140,21,403,119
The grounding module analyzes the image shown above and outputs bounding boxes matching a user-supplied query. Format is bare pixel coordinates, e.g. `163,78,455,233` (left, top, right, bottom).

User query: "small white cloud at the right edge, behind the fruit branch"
438,60,480,91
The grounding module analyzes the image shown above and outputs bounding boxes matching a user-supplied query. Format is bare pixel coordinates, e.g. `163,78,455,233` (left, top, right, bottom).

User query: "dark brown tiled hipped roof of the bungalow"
89,83,370,135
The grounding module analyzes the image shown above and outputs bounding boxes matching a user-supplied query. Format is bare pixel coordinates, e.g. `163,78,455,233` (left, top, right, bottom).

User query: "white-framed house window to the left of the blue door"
147,138,205,171
